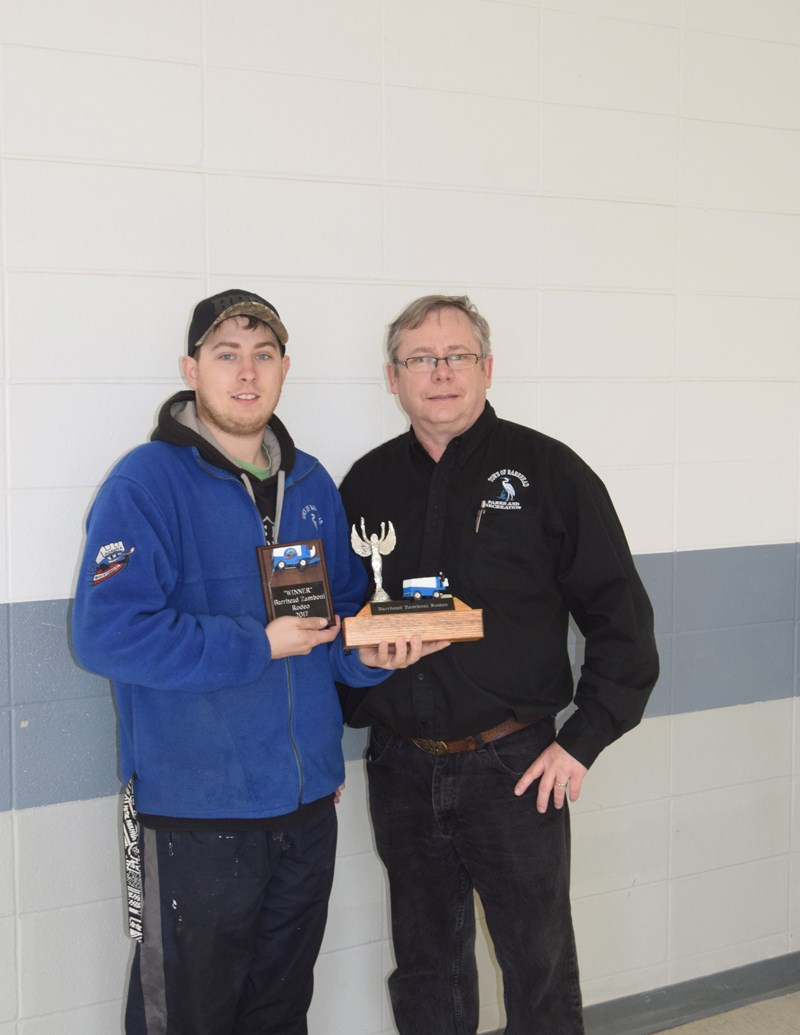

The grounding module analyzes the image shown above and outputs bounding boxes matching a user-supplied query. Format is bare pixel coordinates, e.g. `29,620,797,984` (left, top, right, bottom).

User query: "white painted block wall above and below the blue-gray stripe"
0,0,800,1035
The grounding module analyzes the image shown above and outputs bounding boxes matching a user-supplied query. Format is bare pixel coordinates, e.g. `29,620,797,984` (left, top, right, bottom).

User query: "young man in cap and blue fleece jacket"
72,290,427,1035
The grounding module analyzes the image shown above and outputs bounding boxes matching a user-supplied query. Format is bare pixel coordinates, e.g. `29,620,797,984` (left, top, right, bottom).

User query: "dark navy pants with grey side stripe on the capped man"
125,801,336,1035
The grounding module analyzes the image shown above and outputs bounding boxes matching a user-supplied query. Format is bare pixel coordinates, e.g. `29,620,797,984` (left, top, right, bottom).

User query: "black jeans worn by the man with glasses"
367,719,584,1035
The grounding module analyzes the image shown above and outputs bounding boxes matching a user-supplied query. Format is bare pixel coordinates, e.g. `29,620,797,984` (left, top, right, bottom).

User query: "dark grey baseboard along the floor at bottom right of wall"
484,952,800,1035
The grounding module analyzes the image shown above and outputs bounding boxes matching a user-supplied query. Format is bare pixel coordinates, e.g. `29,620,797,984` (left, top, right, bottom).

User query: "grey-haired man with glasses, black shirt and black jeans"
342,295,658,1035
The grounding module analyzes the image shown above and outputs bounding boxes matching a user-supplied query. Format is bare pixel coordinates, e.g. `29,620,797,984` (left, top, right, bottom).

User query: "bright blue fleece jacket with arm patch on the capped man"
72,442,386,819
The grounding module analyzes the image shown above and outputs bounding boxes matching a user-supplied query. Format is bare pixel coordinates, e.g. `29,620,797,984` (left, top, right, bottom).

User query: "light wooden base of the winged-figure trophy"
342,596,483,649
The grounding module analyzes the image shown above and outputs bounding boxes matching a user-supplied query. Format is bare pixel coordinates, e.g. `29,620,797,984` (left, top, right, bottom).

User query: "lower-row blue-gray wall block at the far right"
672,622,795,714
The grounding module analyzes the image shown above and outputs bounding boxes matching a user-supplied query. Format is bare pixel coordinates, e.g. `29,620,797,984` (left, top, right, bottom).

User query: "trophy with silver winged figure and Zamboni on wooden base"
342,518,483,649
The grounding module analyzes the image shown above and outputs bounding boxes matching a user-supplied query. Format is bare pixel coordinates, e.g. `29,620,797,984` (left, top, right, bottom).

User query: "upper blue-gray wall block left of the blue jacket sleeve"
10,600,109,704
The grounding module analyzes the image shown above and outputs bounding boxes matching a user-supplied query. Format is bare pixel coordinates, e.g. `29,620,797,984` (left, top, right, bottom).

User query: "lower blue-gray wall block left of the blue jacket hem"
12,694,120,808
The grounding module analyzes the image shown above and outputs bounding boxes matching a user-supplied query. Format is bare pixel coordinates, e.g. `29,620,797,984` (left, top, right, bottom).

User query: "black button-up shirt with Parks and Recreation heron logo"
342,404,658,766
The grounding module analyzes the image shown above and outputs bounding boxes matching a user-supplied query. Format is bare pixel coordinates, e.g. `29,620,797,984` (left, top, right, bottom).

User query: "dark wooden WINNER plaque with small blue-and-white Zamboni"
256,539,334,626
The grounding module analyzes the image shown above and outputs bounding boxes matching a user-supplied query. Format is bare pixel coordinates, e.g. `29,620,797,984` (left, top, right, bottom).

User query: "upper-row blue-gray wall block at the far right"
675,542,797,632
